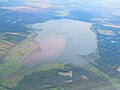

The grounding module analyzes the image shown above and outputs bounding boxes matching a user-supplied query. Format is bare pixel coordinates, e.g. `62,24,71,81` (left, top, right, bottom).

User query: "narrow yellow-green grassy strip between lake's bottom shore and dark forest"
0,63,64,88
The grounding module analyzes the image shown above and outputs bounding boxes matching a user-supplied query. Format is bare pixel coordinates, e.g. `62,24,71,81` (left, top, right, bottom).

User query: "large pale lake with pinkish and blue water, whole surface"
25,19,97,64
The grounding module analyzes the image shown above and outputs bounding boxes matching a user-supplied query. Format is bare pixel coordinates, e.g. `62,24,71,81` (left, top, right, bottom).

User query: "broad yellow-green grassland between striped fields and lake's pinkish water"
0,39,39,75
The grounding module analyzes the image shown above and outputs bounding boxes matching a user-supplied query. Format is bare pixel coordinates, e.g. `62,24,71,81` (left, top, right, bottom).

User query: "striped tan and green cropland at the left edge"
0,32,26,60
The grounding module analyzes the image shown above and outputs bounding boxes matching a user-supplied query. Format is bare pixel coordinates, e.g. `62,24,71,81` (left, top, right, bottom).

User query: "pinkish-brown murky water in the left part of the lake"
24,35,66,64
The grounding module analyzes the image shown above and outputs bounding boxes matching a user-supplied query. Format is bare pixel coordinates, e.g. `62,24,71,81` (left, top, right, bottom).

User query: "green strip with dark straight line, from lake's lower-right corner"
80,50,120,90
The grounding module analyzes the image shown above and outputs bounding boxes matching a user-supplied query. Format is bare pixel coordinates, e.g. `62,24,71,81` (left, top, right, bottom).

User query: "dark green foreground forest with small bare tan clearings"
12,64,116,90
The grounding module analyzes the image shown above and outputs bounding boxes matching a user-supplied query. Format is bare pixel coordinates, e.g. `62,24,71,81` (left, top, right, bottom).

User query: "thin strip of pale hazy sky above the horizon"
0,0,120,5
